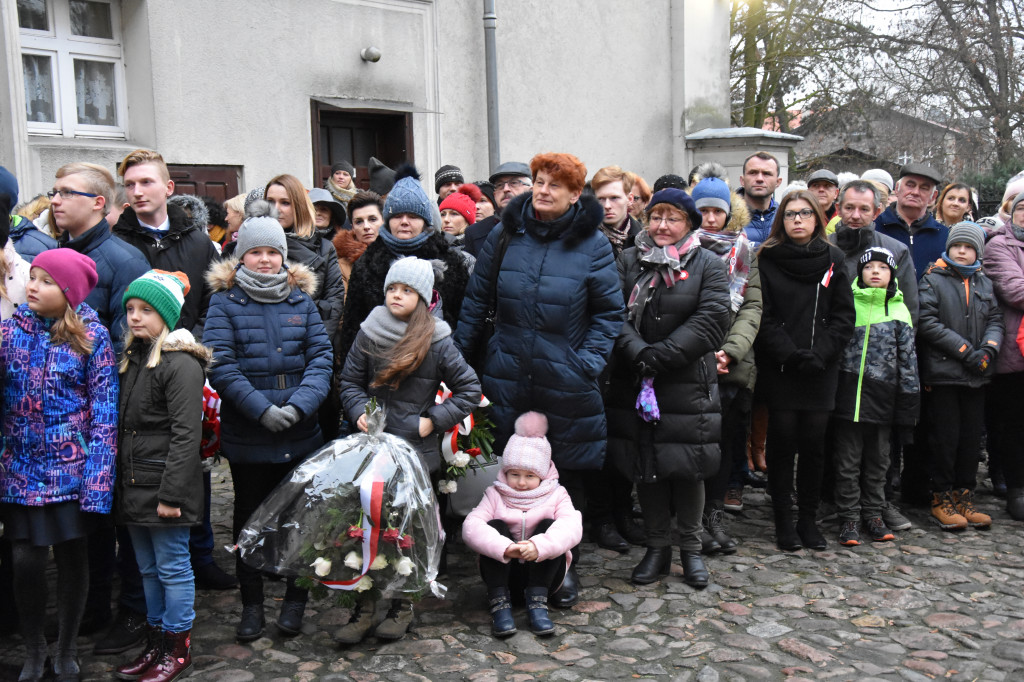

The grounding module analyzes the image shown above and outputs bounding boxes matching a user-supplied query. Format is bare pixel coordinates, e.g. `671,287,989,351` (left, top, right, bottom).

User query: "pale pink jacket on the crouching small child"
462,464,583,565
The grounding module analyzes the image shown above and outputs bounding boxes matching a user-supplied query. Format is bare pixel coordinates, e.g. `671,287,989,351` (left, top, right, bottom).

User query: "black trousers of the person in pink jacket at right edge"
985,372,1024,487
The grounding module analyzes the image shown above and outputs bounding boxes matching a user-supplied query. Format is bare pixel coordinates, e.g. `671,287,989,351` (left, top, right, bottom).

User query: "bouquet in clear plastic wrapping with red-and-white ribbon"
237,403,445,606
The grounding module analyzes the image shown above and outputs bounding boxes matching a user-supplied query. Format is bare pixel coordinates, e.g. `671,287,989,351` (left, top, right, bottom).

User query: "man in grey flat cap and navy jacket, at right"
874,164,949,280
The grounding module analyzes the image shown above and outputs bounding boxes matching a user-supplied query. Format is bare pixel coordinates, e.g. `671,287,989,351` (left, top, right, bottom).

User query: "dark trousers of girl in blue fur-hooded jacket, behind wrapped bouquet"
228,454,308,604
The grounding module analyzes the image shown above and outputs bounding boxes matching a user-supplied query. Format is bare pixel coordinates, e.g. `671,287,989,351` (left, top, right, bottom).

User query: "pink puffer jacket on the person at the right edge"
984,226,1024,374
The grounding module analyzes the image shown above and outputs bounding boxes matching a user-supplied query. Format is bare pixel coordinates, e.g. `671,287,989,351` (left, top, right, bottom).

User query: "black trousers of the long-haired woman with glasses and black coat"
765,410,829,518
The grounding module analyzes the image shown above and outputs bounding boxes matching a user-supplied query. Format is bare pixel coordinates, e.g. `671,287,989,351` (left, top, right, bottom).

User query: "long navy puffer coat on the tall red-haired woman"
455,193,625,469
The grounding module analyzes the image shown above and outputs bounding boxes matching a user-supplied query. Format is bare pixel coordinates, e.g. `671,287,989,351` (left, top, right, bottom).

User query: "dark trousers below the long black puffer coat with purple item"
637,478,705,552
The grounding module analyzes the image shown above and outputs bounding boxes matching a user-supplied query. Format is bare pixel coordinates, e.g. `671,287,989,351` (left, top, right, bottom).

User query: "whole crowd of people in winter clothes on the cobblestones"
0,150,1024,682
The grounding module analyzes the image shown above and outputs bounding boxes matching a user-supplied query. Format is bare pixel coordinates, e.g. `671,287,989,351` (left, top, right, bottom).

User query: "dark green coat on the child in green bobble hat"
114,330,213,525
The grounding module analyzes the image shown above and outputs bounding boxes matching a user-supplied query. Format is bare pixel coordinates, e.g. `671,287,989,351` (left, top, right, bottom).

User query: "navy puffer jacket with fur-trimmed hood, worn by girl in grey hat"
203,260,334,464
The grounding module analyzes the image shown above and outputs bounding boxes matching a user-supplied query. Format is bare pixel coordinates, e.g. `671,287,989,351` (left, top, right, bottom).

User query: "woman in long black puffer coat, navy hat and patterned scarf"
607,188,730,588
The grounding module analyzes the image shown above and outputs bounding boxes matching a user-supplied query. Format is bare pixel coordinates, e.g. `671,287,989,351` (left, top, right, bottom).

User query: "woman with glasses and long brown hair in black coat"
754,190,855,551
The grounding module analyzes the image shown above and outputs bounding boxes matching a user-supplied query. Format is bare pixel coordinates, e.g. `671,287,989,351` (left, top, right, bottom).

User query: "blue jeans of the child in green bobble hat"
128,525,196,632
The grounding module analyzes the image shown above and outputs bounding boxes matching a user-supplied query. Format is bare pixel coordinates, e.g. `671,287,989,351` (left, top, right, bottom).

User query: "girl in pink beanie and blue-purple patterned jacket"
0,249,118,682
